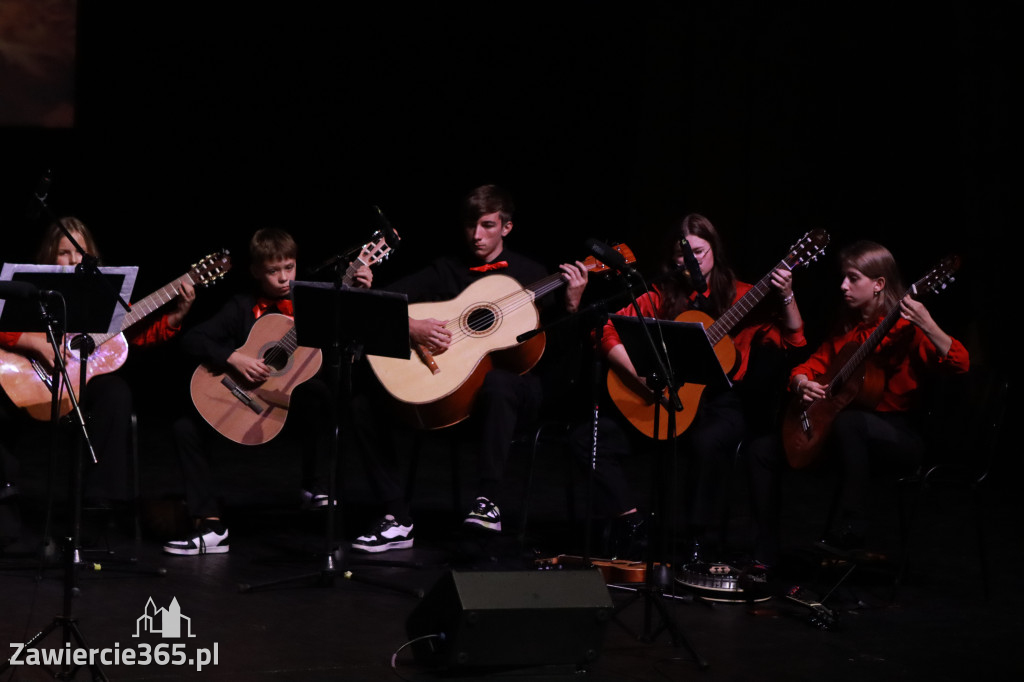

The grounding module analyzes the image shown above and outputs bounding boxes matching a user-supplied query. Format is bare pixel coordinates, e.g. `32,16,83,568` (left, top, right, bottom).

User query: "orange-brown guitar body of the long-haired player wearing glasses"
607,310,738,440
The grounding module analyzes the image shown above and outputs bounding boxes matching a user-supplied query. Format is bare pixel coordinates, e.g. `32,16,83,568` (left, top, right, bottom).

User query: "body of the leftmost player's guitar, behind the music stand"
0,332,128,421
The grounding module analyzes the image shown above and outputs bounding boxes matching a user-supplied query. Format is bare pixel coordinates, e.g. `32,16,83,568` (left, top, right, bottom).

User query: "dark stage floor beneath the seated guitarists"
0,417,1024,682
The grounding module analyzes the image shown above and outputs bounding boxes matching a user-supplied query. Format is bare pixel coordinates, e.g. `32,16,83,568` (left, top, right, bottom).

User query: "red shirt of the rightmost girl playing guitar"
790,316,971,412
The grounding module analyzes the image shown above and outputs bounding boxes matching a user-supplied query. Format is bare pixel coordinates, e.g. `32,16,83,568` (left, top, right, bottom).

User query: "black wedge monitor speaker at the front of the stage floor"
406,568,613,669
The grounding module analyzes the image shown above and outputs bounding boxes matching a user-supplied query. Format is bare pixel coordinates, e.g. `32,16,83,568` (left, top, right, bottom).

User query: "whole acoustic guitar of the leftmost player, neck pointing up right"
0,251,231,421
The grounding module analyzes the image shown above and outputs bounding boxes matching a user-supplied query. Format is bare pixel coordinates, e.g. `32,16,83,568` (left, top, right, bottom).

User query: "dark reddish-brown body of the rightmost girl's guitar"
782,343,885,469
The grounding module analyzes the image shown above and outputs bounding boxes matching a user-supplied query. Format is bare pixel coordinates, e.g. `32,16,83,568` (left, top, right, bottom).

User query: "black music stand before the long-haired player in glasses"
609,315,731,669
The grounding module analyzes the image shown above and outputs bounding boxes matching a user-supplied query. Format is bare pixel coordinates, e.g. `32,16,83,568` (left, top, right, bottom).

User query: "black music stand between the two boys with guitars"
239,282,422,596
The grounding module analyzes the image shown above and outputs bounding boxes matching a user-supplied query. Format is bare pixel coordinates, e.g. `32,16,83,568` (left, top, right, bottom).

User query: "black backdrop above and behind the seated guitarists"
0,0,1015,411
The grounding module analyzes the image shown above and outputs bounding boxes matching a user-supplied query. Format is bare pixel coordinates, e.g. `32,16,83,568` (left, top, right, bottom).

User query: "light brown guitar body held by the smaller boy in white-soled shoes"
191,314,323,445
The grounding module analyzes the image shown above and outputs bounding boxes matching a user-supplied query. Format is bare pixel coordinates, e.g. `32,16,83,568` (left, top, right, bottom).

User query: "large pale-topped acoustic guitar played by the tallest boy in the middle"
367,244,636,429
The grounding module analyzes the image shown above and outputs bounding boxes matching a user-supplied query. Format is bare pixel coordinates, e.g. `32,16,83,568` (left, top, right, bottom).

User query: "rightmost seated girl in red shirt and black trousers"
783,241,970,551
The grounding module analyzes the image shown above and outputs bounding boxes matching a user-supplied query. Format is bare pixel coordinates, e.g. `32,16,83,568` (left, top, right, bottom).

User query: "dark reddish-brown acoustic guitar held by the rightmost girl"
782,255,961,469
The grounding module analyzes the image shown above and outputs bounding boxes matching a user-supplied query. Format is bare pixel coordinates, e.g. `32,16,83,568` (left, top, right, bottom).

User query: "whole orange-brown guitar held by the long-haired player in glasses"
607,229,829,440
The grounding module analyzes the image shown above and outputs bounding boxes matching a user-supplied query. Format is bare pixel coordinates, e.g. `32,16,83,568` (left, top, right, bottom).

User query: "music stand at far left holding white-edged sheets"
0,263,138,680
